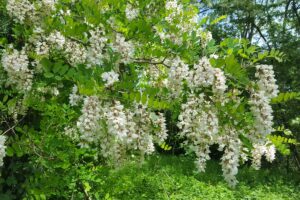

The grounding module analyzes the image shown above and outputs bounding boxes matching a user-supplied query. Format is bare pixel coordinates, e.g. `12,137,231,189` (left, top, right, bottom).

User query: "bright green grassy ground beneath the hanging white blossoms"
102,156,300,200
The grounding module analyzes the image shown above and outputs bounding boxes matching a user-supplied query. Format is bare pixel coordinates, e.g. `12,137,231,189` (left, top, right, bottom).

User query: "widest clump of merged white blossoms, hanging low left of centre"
77,97,167,164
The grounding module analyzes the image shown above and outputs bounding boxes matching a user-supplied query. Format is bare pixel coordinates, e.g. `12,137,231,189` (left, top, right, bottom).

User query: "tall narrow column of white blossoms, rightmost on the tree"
249,65,278,169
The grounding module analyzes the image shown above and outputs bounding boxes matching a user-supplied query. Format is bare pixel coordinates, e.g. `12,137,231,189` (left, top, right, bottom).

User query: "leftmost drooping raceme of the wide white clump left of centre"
77,96,101,146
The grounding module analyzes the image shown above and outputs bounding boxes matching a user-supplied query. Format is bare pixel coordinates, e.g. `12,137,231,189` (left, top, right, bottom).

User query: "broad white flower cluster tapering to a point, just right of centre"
178,94,219,171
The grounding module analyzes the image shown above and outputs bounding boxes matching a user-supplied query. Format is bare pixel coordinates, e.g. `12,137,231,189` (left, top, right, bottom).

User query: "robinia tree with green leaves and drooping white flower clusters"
0,0,279,195
